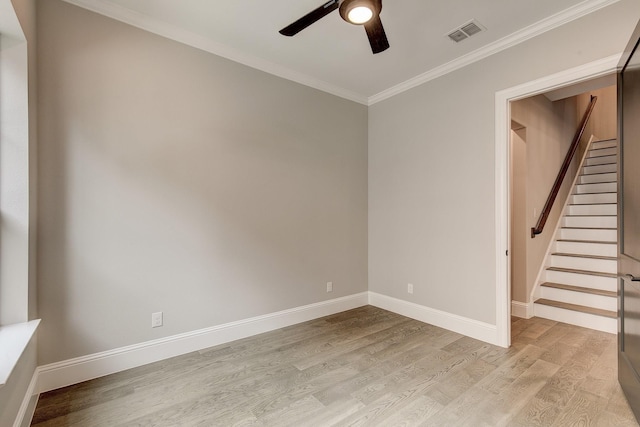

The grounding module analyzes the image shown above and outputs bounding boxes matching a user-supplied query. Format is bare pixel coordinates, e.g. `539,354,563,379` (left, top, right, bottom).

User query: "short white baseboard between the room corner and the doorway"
369,292,500,345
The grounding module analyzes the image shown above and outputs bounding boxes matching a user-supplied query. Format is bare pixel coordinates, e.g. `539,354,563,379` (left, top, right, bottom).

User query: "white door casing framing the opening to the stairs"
495,55,620,346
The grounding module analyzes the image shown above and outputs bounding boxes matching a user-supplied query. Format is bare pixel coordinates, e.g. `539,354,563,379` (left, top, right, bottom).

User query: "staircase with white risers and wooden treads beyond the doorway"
534,140,618,333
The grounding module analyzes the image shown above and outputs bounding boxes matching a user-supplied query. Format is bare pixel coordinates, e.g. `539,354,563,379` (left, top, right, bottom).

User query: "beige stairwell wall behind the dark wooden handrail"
511,95,580,303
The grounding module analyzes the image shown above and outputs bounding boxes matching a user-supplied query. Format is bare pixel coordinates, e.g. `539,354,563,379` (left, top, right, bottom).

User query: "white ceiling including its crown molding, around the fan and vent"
65,0,618,104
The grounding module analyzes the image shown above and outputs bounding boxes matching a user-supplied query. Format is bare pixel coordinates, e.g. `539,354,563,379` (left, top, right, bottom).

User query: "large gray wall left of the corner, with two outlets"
38,0,367,364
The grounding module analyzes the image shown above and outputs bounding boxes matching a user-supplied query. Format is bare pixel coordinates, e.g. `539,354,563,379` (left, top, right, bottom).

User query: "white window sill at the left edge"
0,319,40,388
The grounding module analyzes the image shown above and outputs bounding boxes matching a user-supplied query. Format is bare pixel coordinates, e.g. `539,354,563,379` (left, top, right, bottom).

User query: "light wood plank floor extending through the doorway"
32,306,638,427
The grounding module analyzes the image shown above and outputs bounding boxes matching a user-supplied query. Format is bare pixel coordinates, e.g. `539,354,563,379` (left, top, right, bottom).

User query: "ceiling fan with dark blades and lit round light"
280,0,389,54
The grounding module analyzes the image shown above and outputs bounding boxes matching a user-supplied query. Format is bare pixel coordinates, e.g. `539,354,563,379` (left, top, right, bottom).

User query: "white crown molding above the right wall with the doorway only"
368,0,620,106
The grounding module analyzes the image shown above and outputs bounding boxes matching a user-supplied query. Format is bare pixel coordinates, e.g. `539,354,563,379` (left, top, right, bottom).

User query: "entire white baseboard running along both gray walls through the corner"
31,292,500,402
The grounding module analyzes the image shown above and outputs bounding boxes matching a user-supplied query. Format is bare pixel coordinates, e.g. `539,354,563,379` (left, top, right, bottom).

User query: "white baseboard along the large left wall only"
36,292,368,393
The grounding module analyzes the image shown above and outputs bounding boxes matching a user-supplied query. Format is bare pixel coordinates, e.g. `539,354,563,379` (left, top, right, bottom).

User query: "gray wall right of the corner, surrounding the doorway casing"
369,0,638,324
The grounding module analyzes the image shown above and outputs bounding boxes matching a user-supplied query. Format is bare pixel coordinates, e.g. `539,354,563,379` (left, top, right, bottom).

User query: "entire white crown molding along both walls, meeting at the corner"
64,0,620,106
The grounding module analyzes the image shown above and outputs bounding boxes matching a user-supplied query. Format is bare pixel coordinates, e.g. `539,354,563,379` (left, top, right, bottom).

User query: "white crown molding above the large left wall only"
63,0,368,105
